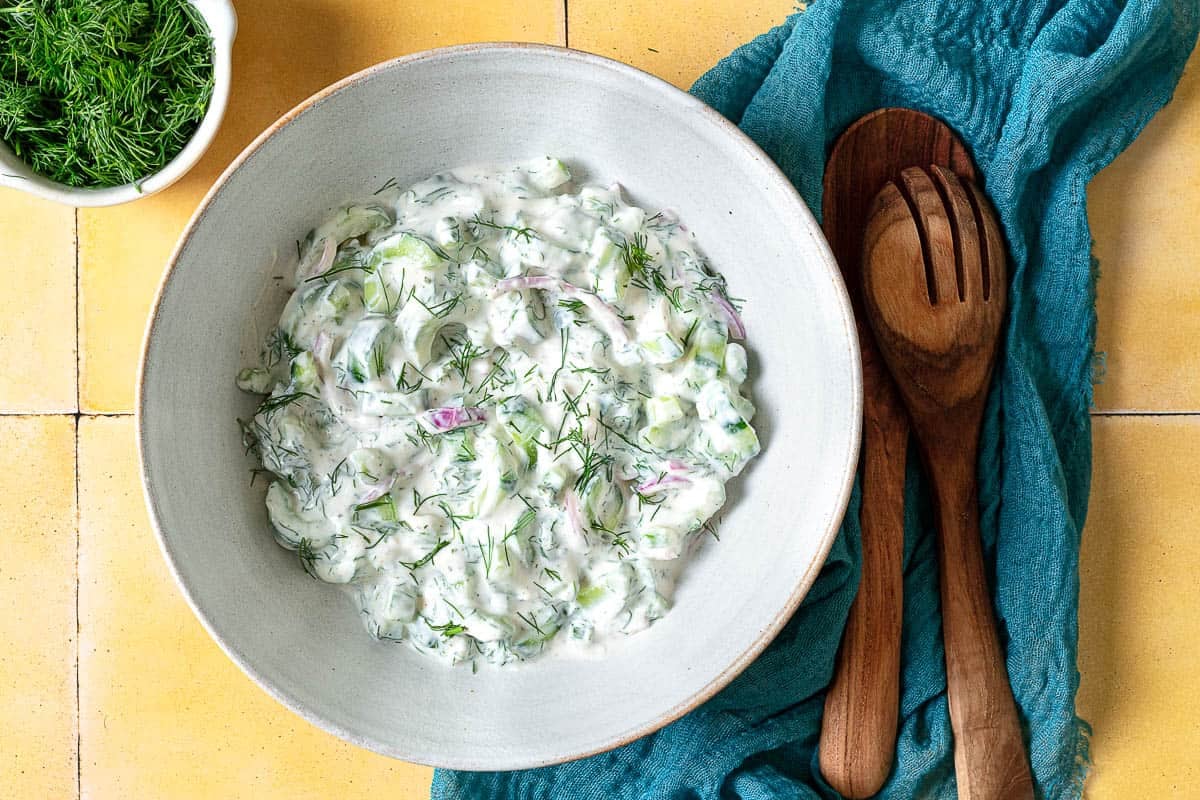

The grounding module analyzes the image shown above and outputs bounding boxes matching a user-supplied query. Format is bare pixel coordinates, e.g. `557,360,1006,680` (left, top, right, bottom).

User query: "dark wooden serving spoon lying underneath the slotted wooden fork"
820,108,976,798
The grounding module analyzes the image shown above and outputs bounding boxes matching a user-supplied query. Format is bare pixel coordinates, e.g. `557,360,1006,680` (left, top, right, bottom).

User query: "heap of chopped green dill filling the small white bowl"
0,0,212,187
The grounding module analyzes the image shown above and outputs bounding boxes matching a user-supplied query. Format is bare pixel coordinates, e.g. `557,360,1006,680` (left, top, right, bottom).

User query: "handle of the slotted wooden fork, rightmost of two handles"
930,452,1033,800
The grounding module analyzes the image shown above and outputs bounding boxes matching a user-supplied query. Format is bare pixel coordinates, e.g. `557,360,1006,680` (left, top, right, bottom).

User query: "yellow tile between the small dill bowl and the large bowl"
79,0,564,411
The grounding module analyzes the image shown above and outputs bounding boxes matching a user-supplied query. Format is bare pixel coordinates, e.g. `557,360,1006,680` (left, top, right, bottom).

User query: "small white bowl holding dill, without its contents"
0,0,238,207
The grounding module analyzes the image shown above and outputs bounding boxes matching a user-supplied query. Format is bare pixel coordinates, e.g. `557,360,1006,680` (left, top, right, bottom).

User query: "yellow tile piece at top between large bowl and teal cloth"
568,0,796,89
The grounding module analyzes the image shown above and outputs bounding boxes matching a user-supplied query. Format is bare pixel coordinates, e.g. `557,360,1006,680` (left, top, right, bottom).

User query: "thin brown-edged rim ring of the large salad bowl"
134,42,863,771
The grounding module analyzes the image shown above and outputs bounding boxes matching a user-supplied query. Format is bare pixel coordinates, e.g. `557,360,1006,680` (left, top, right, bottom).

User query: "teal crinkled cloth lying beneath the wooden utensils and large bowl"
433,0,1200,800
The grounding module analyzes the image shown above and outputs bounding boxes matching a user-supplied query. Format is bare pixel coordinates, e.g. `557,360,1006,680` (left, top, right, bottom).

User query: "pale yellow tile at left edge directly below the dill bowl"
0,188,76,413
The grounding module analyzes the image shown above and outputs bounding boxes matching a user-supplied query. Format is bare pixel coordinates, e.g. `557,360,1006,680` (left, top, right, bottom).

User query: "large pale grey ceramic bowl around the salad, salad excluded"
138,44,862,769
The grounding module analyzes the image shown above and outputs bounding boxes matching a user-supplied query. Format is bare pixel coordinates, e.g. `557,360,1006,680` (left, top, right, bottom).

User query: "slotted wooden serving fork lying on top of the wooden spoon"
863,167,1033,800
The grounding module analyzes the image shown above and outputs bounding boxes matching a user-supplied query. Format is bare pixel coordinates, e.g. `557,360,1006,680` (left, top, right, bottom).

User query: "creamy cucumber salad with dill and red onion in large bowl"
238,158,758,664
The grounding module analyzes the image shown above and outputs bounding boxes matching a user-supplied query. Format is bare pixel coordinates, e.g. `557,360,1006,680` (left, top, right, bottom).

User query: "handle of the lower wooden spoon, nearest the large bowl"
820,407,908,799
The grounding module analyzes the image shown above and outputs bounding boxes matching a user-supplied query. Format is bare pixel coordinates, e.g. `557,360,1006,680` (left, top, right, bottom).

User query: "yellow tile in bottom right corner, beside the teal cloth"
1079,416,1200,800
